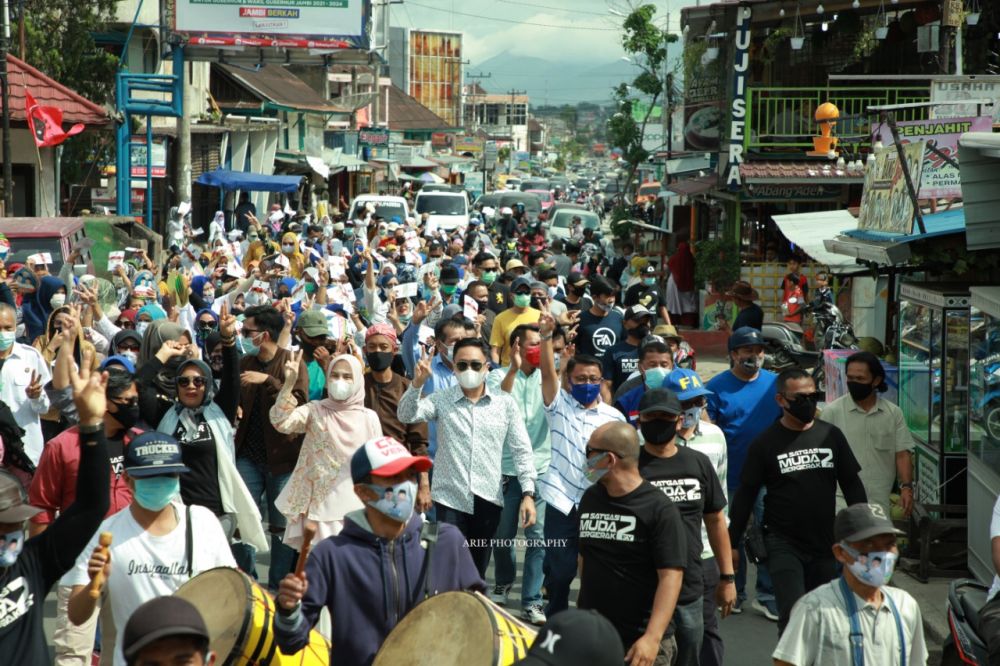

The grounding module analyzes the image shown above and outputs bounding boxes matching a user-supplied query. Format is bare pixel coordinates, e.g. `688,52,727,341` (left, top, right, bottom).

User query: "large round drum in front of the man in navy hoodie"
375,592,535,666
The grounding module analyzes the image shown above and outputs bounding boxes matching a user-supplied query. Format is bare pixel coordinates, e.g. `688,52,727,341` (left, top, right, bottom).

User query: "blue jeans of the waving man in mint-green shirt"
493,476,545,608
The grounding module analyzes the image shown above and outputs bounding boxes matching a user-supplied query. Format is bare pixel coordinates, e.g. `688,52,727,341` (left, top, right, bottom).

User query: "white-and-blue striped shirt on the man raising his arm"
539,389,625,516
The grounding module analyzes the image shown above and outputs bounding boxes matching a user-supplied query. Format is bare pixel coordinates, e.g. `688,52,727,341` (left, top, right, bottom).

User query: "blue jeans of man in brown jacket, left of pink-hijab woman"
233,458,298,592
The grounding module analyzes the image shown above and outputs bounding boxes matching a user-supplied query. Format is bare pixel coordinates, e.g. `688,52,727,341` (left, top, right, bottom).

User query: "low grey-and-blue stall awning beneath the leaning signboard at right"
824,208,965,266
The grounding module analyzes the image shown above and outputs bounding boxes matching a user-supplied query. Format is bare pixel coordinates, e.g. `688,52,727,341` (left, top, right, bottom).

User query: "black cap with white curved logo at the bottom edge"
516,608,625,666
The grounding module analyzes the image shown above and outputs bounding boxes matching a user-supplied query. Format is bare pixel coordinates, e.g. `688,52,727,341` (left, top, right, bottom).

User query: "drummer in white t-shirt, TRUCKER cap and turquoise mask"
63,431,236,666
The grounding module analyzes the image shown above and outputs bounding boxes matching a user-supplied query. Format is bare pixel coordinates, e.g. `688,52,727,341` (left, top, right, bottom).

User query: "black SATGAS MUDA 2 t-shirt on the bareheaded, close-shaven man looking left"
577,481,687,649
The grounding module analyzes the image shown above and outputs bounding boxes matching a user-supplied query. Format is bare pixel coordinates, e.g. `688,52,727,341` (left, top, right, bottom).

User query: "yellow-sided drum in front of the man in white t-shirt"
174,567,330,666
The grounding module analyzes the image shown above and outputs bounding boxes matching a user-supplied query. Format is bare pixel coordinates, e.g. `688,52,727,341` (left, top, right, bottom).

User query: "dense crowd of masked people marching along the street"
0,198,926,666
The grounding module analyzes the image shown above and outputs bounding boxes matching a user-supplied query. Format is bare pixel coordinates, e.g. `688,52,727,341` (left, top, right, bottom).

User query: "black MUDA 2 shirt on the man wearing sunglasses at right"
729,420,866,555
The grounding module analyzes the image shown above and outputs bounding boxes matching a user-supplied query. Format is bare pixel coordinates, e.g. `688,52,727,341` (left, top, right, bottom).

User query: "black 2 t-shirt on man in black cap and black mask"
639,446,726,604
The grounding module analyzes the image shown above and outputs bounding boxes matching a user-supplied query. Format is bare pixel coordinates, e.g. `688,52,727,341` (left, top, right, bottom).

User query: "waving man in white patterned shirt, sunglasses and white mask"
398,338,551,576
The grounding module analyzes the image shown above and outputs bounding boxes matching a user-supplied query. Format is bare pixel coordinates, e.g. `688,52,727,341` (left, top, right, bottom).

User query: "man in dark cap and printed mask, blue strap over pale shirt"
771,503,927,666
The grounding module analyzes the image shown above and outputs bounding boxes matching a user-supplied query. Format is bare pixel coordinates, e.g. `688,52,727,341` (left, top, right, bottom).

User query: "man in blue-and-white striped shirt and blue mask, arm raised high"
538,313,625,616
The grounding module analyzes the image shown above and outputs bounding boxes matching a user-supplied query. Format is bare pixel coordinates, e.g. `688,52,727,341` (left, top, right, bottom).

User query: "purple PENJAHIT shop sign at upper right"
872,116,993,199
